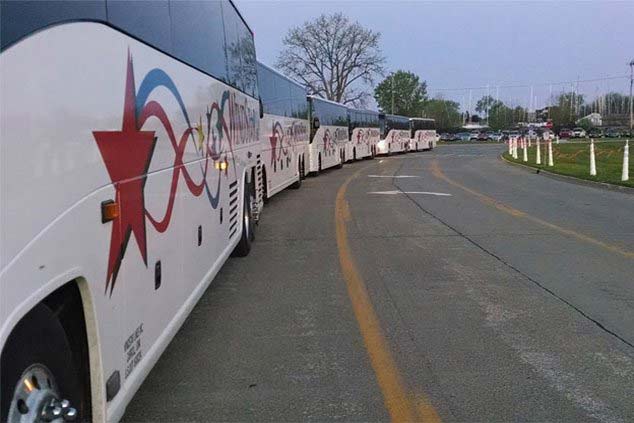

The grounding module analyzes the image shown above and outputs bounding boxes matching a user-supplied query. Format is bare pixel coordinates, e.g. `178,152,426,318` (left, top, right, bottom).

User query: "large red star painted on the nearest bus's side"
93,52,156,295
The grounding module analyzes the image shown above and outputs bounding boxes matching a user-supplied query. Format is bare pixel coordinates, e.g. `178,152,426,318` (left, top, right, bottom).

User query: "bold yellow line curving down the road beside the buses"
335,166,440,422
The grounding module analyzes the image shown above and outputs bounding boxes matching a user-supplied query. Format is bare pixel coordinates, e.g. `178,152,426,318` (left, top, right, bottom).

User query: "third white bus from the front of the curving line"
308,96,348,175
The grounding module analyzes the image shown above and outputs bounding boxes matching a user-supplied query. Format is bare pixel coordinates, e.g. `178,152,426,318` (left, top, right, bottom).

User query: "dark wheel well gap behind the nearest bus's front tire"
42,281,91,409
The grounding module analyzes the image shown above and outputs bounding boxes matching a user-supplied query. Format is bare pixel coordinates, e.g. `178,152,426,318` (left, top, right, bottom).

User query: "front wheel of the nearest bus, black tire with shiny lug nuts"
0,304,90,422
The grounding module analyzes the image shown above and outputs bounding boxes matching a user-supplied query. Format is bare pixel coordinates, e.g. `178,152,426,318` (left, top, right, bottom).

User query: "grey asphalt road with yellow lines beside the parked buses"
125,145,634,422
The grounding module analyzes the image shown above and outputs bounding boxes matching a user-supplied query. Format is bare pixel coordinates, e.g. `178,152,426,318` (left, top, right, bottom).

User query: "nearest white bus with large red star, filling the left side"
0,0,261,422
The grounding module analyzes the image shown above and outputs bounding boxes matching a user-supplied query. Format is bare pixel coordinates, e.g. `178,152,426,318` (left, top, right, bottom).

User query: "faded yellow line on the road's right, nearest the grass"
431,160,634,259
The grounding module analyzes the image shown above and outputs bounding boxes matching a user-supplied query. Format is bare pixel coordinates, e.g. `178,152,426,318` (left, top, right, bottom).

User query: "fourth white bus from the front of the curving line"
346,108,380,160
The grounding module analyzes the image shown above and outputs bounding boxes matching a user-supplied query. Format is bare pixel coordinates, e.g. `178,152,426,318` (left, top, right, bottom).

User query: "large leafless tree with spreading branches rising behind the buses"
276,13,385,105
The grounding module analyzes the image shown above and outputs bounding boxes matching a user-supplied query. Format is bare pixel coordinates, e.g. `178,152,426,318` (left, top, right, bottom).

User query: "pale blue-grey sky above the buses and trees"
235,0,634,112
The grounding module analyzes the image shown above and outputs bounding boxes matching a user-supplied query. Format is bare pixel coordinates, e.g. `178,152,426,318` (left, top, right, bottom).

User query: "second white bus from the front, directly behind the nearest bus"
258,62,309,200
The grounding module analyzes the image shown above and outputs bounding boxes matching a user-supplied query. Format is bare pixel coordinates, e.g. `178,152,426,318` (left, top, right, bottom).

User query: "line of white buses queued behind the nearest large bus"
258,62,436,199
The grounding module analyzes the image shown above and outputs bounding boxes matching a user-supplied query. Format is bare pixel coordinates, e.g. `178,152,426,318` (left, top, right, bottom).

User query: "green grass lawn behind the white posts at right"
504,141,634,187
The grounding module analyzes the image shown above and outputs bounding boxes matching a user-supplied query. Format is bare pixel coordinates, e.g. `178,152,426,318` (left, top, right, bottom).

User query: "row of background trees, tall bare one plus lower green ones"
275,13,627,131
